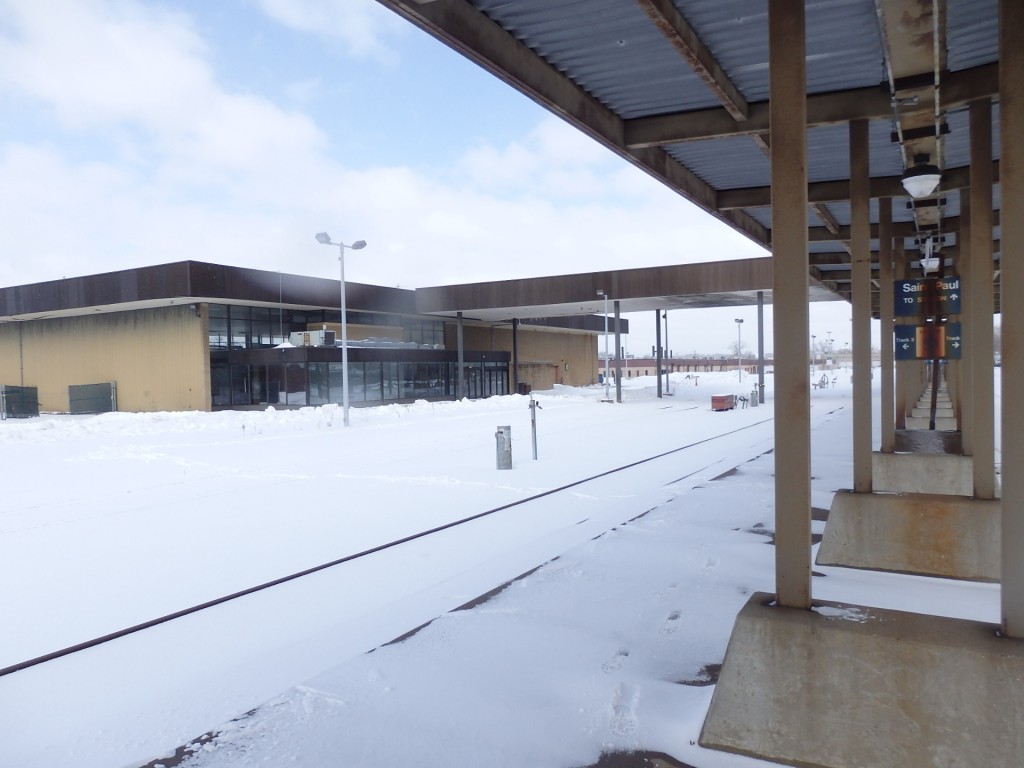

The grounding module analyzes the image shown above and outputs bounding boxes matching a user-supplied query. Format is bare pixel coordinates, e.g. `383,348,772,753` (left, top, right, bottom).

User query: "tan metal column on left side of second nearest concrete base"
850,120,871,494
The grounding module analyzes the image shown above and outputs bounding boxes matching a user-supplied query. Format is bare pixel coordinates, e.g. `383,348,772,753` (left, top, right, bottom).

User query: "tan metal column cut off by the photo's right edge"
999,0,1024,638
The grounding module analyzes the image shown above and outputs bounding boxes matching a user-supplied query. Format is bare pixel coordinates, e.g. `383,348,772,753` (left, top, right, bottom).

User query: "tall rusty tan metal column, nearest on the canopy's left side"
768,0,811,608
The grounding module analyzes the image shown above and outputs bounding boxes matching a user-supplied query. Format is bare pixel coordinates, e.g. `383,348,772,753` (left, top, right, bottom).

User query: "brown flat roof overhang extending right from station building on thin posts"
416,257,844,323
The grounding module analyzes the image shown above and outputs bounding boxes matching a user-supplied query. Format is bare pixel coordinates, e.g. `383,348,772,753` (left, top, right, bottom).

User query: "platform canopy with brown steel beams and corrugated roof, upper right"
379,0,1000,312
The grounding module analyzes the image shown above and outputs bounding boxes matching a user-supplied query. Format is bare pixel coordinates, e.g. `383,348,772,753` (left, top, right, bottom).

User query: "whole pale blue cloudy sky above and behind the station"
0,0,864,354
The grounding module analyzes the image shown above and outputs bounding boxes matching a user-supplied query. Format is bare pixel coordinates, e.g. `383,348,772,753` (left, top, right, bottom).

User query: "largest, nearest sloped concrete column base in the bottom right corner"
700,593,1024,768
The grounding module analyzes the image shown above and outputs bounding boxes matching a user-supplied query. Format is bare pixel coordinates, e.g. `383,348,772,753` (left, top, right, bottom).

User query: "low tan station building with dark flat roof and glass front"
0,261,610,413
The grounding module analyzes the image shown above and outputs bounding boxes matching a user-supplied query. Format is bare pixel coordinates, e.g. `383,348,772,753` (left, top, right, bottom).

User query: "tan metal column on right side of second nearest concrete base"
965,98,995,499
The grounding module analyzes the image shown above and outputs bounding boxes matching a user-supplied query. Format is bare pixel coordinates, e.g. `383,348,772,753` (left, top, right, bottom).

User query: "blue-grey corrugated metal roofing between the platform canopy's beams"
393,0,999,307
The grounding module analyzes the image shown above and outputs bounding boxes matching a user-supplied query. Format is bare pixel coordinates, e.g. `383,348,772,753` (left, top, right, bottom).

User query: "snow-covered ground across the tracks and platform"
0,373,998,768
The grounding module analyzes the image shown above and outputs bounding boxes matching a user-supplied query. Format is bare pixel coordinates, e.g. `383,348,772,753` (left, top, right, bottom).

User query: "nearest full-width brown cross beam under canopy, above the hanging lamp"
624,63,999,148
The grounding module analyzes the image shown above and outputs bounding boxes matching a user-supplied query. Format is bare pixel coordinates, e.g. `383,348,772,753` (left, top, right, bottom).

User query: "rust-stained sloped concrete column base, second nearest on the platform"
815,490,1001,582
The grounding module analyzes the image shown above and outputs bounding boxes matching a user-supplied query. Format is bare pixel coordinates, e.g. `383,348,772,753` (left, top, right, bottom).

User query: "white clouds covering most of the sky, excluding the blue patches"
0,0,815,354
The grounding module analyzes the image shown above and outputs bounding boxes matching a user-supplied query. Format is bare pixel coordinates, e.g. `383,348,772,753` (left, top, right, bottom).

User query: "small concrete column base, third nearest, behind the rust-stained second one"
871,453,974,496
